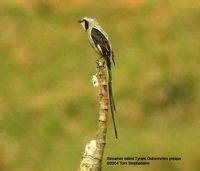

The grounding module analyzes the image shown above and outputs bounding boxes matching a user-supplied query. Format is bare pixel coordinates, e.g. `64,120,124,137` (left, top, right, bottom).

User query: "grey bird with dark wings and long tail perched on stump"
78,17,118,138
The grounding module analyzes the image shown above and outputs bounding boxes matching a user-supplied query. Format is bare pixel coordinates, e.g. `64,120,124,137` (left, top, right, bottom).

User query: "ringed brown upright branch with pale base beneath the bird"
77,64,108,171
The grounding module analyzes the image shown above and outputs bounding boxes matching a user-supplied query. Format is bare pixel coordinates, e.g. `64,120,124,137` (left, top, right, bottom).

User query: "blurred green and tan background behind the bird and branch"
0,0,200,171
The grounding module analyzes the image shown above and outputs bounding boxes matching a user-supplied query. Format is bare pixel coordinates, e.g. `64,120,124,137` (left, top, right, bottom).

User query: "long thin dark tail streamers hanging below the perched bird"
107,64,118,138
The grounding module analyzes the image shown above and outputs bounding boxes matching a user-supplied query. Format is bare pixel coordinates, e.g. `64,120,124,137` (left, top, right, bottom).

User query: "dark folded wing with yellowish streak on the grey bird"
91,28,112,58
